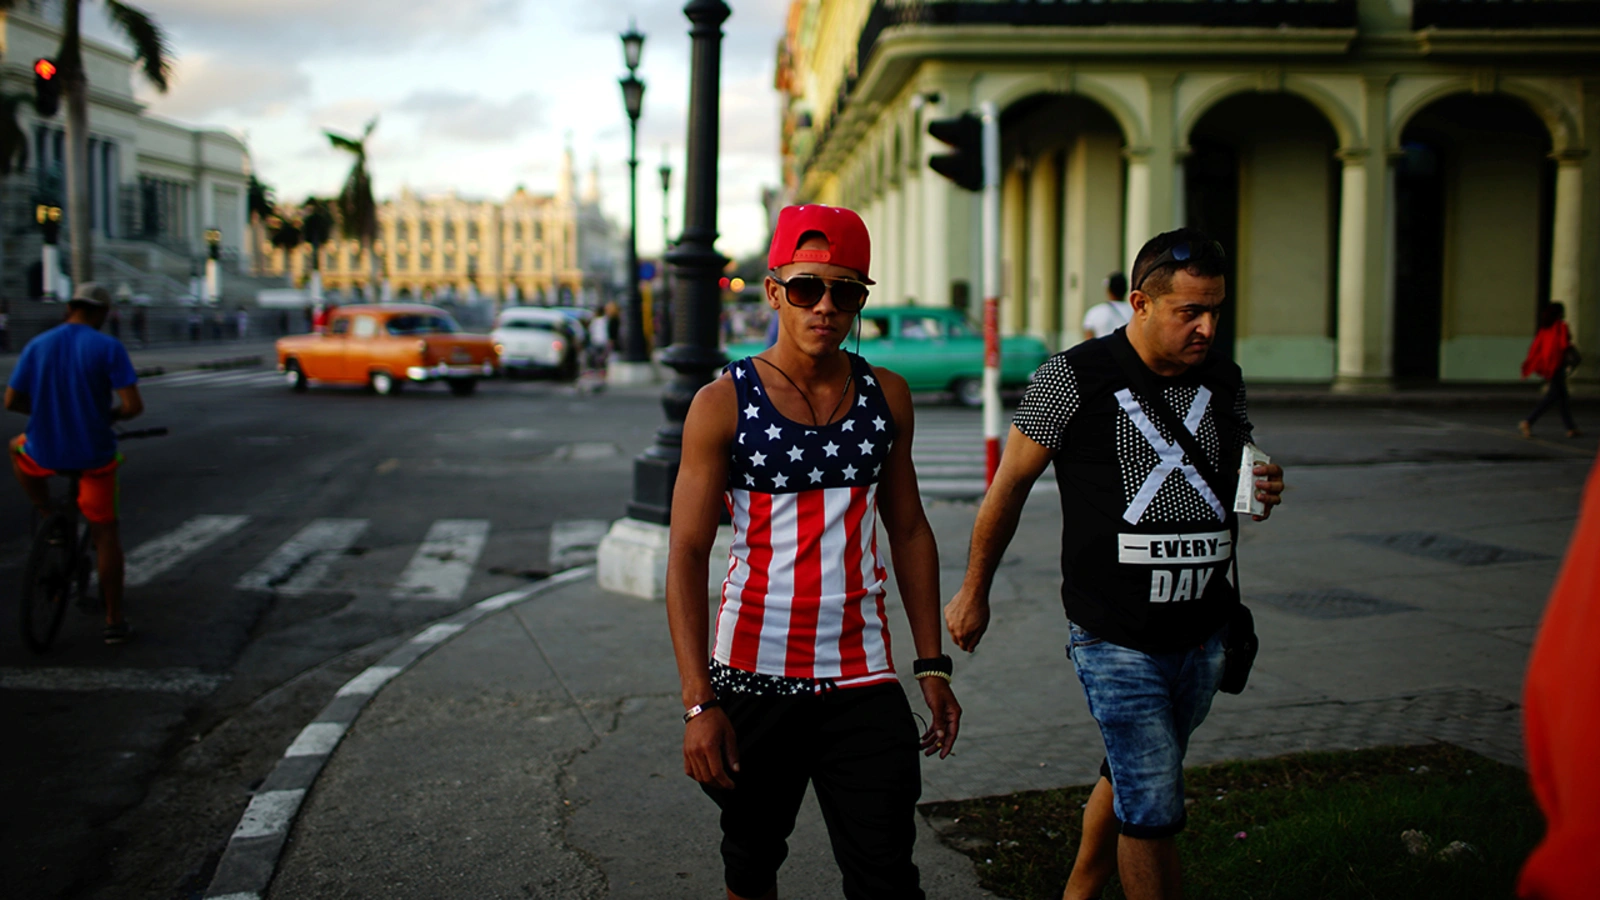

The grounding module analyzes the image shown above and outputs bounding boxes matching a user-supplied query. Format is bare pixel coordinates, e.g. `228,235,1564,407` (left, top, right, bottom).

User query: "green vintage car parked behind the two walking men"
726,306,1050,407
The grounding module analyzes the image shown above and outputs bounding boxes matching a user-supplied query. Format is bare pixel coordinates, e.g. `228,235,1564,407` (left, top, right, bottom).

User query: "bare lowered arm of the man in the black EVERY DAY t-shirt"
944,426,1056,652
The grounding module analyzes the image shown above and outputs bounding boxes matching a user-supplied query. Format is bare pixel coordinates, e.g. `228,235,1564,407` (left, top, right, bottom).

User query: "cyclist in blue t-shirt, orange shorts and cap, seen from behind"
5,282,144,644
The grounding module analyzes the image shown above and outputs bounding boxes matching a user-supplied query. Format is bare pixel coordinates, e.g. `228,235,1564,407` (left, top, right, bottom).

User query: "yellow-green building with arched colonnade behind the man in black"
778,0,1600,381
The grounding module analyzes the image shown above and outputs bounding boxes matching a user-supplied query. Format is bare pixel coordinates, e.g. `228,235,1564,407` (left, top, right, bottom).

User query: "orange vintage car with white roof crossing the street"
277,303,499,397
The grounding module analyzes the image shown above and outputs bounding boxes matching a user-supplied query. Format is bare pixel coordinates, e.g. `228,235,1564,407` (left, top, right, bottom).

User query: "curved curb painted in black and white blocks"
202,565,595,900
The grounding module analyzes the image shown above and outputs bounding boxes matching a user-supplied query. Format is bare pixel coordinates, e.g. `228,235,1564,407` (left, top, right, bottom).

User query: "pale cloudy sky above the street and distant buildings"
95,0,787,256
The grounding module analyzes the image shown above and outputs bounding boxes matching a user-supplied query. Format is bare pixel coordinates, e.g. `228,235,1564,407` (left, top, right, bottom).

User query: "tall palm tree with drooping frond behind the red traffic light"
9,0,173,283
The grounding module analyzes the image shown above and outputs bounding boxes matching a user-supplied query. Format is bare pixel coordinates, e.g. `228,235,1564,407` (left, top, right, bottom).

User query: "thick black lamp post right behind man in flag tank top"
627,0,730,525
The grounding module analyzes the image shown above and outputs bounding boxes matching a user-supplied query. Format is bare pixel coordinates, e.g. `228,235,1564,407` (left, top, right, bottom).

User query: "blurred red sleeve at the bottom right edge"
1517,454,1600,900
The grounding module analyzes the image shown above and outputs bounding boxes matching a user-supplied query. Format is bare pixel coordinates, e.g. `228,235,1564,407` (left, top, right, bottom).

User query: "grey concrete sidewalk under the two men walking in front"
246,435,1590,898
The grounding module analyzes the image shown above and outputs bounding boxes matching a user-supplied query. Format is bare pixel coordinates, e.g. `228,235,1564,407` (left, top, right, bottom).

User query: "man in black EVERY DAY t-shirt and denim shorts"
946,229,1283,900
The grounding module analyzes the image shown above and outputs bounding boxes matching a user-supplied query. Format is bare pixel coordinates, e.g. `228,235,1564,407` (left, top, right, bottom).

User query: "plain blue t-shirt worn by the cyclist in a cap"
10,323,139,469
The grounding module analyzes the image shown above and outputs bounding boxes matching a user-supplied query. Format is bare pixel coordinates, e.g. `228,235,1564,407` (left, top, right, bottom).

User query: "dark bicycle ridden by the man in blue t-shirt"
19,428,166,653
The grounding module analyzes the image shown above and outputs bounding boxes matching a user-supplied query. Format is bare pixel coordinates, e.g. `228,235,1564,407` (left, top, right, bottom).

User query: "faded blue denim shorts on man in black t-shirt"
1067,614,1227,838
